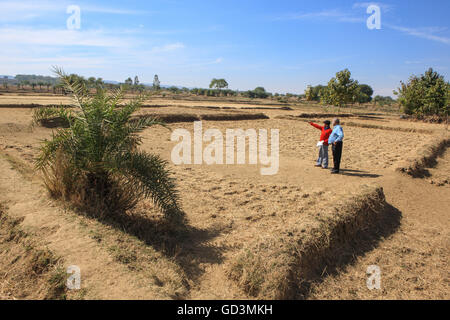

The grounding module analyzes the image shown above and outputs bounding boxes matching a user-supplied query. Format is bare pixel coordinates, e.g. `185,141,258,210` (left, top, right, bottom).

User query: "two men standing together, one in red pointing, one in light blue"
309,119,344,174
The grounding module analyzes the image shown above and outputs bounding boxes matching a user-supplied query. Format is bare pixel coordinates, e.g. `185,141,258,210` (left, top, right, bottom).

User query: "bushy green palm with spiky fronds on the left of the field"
36,68,182,217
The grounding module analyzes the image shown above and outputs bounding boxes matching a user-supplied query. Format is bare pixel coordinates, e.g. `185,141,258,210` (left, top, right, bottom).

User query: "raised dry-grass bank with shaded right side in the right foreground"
229,187,399,299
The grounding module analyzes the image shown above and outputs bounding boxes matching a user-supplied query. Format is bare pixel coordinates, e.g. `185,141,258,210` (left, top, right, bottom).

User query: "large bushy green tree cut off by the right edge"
394,68,450,117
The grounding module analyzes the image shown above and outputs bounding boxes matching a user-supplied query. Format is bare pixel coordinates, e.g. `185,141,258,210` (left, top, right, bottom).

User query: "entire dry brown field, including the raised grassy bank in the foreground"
0,95,450,299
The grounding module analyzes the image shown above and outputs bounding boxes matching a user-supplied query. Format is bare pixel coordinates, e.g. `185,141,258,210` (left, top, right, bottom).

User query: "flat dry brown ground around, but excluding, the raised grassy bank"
0,97,450,299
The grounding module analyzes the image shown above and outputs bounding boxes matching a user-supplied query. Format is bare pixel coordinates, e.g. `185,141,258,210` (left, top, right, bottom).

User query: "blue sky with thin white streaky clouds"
0,0,450,96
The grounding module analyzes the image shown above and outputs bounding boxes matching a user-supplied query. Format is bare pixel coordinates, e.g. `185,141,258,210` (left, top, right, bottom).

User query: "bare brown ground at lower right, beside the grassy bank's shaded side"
310,171,450,299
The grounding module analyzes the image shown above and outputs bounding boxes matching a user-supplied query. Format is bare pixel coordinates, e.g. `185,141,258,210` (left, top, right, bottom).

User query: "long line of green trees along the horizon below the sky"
3,68,450,117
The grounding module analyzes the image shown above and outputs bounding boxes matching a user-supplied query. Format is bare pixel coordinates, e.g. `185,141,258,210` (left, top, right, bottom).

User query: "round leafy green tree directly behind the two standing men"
327,69,359,109
